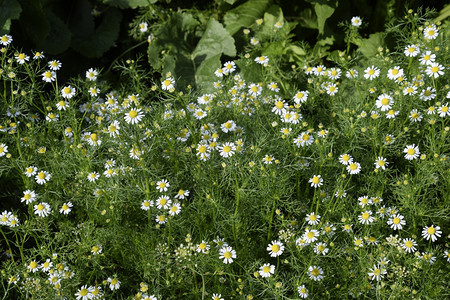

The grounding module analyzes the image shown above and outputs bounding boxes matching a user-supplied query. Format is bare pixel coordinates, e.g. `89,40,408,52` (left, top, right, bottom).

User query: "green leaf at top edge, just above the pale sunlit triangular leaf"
223,0,272,35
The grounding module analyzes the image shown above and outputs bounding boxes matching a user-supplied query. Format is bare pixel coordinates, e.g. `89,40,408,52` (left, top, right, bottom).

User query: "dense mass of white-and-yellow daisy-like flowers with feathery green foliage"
0,8,450,300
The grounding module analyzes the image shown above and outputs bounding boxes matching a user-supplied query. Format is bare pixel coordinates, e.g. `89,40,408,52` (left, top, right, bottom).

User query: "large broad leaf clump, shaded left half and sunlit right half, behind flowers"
148,13,236,88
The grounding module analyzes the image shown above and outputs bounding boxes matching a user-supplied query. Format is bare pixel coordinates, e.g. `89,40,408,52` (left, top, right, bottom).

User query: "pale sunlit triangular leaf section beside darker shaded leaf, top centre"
192,18,236,60
